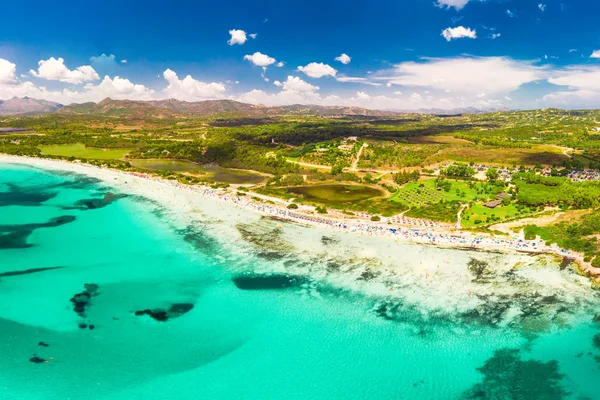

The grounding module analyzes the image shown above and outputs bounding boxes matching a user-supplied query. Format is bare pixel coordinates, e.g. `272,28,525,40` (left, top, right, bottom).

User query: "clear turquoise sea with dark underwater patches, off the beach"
0,164,600,400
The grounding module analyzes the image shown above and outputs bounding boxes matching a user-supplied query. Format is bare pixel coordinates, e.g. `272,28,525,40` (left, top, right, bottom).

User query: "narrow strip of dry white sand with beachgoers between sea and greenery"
0,155,600,283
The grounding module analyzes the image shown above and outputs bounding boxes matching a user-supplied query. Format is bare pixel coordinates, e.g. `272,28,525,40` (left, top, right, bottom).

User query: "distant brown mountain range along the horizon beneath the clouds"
0,97,508,118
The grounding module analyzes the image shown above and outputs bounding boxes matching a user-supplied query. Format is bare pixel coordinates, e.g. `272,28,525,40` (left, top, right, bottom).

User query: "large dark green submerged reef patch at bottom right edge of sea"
463,349,568,400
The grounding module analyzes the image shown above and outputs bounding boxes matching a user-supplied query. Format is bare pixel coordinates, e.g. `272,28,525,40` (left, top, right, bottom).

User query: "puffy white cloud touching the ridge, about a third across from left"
163,69,227,101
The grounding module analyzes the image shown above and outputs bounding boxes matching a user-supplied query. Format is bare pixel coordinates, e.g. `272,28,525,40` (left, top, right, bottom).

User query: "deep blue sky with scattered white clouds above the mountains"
0,0,600,109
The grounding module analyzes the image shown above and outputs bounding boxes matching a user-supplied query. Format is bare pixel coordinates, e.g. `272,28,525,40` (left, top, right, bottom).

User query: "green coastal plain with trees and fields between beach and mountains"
0,106,600,234
